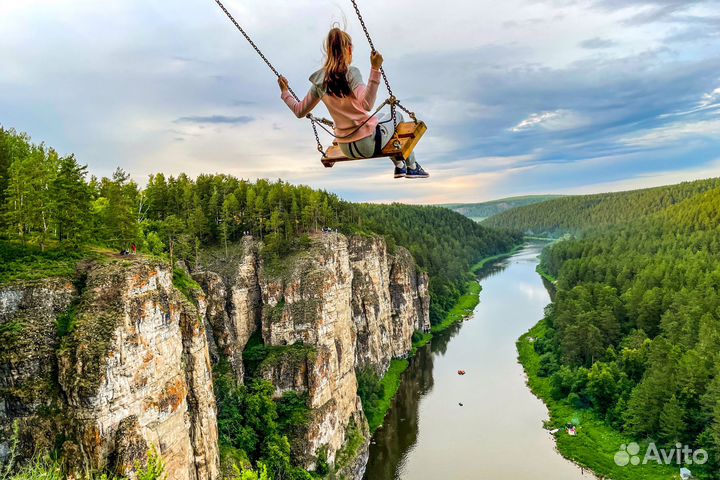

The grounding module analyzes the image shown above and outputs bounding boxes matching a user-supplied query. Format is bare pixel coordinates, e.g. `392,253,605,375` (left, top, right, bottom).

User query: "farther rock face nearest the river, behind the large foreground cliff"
193,233,429,472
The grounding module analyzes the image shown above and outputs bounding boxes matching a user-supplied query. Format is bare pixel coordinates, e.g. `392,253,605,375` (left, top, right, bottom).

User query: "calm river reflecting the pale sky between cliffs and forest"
365,242,592,480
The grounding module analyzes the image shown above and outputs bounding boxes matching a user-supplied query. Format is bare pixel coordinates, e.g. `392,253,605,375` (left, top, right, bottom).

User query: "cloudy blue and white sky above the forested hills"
0,0,720,203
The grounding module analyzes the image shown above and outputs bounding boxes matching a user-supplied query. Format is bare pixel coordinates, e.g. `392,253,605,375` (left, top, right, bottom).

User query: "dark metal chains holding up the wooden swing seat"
214,0,418,157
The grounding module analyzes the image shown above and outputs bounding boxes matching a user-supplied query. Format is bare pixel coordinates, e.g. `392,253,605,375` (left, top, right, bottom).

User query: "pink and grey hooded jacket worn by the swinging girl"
281,67,380,143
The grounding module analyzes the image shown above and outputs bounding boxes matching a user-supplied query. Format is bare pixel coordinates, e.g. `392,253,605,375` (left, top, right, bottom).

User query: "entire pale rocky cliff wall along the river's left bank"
0,233,429,480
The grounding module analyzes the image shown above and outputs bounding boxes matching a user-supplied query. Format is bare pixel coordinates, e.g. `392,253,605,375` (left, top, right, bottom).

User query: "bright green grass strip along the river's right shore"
517,320,679,480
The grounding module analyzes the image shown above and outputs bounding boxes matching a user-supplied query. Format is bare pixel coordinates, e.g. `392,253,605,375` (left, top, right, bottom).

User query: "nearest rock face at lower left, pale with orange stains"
2,260,219,480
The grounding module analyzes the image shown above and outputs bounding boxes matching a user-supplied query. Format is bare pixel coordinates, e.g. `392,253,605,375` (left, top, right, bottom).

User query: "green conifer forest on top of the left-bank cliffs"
0,129,522,323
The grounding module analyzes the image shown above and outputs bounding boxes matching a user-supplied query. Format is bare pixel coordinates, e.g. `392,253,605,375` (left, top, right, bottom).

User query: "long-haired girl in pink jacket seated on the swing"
278,28,430,178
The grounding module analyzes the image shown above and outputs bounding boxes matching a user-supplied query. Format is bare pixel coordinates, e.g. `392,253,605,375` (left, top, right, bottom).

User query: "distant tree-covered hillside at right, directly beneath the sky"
482,178,720,237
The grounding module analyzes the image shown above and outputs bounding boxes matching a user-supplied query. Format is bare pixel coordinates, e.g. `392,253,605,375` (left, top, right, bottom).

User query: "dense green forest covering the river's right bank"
520,183,720,479
